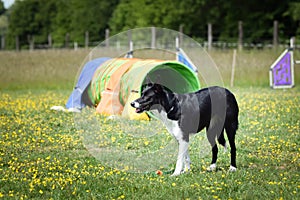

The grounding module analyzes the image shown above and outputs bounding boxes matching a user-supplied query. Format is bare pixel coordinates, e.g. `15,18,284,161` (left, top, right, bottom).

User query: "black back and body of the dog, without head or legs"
172,87,239,137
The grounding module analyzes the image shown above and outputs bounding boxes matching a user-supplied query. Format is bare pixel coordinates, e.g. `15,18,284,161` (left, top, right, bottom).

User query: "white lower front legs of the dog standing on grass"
172,139,189,176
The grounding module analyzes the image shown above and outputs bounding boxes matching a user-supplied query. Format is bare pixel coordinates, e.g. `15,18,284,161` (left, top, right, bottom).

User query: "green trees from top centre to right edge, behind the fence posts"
110,0,300,43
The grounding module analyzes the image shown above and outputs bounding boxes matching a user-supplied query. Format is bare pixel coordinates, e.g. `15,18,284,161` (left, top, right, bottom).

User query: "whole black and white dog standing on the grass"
131,83,239,176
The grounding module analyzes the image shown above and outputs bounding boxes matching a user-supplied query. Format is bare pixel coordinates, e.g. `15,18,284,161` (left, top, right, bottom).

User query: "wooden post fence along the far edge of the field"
0,21,300,51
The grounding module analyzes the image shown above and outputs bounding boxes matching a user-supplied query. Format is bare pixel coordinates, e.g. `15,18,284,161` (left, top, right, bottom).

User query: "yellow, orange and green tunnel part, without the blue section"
89,58,200,115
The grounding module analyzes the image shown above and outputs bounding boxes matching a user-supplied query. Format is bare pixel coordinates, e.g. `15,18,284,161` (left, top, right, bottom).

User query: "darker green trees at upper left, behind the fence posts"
9,0,118,46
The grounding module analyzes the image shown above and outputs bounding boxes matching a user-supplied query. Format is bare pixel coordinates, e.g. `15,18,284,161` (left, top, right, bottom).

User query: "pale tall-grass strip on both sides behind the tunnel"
0,49,300,90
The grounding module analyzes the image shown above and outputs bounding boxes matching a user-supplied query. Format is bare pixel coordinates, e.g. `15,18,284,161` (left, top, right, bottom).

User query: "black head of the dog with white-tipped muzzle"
130,83,164,113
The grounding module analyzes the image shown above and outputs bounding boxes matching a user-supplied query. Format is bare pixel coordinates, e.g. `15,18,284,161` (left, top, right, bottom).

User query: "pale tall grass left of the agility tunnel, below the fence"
0,50,88,90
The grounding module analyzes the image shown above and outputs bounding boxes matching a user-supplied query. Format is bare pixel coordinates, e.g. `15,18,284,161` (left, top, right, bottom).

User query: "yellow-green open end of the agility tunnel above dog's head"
120,61,200,104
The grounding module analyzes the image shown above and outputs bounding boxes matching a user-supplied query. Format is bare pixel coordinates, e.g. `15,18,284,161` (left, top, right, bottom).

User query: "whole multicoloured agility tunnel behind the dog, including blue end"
66,58,200,119
